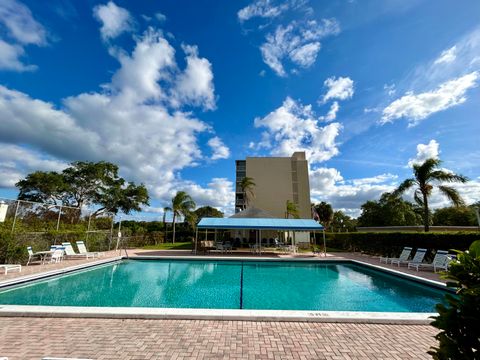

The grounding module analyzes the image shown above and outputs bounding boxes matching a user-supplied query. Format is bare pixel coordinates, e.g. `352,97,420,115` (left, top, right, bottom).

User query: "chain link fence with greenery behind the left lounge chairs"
0,198,117,263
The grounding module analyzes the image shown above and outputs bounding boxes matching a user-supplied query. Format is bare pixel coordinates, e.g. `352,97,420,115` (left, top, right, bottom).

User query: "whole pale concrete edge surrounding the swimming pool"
0,256,447,325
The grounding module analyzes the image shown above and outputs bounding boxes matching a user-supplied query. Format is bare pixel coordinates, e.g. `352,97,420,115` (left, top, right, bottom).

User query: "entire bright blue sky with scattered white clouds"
0,0,480,216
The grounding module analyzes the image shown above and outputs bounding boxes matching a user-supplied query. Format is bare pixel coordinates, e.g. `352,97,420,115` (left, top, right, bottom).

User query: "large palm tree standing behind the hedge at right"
393,159,468,231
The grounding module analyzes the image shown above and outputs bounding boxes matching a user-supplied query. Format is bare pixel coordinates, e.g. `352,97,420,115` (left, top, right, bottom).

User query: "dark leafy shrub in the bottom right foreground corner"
429,241,480,360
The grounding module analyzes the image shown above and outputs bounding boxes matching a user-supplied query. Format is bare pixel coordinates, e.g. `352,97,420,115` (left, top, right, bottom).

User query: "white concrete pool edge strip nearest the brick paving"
0,305,437,325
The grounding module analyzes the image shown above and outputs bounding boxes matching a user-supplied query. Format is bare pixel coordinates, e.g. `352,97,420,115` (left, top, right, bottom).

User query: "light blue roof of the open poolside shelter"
197,218,323,231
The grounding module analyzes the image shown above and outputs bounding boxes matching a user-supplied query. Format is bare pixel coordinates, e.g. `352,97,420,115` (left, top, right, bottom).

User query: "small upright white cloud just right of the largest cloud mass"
174,45,215,110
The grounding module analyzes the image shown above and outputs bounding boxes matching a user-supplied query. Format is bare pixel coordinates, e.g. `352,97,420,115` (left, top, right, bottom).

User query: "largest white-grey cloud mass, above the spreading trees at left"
0,29,225,208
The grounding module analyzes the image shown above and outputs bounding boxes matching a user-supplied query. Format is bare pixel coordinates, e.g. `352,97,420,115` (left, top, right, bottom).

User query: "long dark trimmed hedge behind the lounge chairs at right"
326,232,480,256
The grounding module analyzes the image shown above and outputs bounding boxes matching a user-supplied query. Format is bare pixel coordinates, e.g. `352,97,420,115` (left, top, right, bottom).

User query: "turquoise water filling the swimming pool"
0,260,445,312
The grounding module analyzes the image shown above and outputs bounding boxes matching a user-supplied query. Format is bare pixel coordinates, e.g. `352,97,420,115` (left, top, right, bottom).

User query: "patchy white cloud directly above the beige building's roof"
255,97,342,164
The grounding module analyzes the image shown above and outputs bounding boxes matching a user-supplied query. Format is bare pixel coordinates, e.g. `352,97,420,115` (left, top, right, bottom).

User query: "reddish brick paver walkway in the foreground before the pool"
0,318,436,360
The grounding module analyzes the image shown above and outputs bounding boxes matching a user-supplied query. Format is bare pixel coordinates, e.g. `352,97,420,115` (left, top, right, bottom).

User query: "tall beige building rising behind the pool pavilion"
235,152,312,219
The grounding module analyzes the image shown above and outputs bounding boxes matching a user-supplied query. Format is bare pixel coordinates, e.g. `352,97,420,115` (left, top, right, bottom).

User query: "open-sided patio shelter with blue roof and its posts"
195,217,326,256
